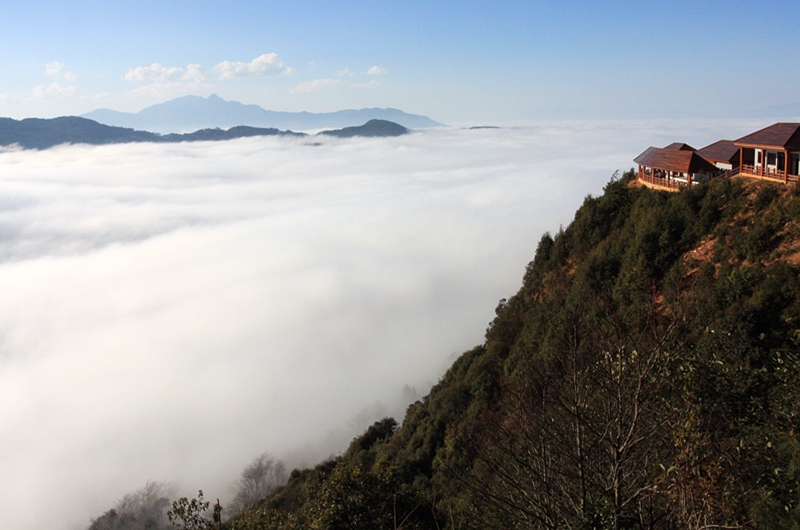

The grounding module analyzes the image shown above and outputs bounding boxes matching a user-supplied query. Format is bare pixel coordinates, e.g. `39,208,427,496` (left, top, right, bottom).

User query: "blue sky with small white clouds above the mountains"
0,0,800,123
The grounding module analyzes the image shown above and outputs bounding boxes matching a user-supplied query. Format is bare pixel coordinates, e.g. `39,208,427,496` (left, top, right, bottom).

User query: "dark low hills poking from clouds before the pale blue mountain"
0,116,409,149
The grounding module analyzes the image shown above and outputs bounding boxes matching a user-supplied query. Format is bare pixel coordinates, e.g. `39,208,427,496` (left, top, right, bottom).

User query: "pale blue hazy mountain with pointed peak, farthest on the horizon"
81,94,442,133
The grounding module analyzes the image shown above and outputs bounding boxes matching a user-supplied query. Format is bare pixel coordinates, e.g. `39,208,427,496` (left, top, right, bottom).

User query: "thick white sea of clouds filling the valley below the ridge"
0,121,776,530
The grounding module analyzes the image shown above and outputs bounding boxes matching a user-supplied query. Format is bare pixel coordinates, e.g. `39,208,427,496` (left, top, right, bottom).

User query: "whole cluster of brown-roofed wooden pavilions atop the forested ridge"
634,123,800,191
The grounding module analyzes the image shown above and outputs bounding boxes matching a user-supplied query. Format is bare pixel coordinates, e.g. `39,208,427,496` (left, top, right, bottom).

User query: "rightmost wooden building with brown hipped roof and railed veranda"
734,123,800,182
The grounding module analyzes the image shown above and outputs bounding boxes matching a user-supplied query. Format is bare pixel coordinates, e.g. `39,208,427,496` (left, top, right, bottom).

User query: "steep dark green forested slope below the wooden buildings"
94,172,800,530
